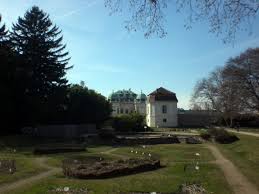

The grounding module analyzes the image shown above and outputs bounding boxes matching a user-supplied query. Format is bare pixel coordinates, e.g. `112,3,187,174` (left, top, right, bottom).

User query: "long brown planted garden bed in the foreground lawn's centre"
62,158,161,179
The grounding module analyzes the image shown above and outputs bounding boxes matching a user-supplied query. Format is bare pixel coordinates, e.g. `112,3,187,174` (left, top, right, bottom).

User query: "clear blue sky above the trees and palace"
0,0,259,109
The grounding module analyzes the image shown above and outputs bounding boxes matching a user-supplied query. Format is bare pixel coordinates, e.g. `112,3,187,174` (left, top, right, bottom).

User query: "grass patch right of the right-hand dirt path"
218,135,259,189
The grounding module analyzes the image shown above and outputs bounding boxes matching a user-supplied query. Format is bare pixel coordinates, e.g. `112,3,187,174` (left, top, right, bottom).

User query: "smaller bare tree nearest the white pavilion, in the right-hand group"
191,68,245,127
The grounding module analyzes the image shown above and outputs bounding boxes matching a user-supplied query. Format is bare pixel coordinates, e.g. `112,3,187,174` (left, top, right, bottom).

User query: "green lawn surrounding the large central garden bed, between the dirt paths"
5,144,232,194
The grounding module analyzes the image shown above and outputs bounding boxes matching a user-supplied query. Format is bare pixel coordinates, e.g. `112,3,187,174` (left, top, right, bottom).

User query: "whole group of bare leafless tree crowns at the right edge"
191,48,259,125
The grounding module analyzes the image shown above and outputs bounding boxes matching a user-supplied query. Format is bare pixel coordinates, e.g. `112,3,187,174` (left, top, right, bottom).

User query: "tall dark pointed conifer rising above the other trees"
10,6,71,125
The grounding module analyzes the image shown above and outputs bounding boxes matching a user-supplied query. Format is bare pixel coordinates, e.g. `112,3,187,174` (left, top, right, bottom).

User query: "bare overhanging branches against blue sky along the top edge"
105,0,259,42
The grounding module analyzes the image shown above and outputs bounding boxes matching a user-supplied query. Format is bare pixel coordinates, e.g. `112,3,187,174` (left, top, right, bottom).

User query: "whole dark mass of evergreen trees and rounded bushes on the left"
0,6,111,133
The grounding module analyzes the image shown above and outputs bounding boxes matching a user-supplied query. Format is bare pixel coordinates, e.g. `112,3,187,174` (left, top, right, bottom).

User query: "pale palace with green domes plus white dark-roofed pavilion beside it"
108,87,178,127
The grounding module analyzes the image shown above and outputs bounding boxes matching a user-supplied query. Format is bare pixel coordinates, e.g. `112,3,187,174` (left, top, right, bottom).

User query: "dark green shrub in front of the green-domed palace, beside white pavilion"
112,113,145,132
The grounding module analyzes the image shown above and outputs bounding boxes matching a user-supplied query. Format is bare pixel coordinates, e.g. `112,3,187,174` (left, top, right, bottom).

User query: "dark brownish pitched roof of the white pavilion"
148,87,178,102
